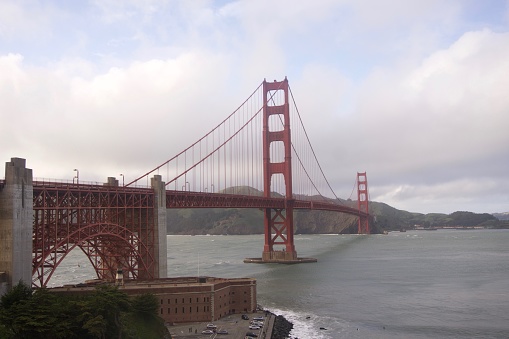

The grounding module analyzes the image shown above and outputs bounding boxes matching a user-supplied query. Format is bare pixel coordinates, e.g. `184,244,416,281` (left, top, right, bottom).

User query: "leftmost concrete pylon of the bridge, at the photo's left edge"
0,158,34,290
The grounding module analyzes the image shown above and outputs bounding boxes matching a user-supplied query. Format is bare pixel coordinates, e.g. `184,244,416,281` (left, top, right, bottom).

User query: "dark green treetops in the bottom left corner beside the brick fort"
0,282,170,339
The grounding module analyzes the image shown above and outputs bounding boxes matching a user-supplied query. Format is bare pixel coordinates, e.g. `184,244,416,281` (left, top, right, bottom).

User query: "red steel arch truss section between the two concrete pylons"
32,182,157,287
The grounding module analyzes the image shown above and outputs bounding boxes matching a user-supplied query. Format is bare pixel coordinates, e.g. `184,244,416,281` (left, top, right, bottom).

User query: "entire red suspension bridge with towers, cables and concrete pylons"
0,79,370,286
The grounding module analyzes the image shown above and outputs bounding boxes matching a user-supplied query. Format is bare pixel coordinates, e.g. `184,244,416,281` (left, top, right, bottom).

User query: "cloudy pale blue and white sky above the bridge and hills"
0,0,509,213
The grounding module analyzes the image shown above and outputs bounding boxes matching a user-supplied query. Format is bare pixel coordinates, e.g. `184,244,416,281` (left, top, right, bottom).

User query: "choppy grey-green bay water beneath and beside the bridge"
50,230,509,339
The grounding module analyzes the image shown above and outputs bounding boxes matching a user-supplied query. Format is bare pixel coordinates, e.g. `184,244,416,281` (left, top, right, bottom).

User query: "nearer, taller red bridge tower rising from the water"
262,78,297,261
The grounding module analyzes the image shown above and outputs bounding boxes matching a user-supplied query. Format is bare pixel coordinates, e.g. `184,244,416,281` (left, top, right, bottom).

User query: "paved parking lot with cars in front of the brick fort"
168,311,274,339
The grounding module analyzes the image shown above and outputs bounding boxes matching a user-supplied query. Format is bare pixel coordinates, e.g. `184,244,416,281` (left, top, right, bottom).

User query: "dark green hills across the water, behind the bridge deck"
167,187,509,235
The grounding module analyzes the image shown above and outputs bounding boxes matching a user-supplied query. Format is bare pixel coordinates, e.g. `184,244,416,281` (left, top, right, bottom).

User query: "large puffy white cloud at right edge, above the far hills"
352,31,509,166
